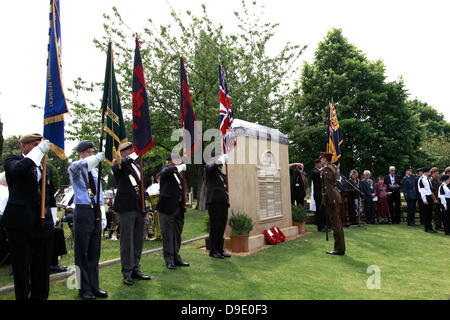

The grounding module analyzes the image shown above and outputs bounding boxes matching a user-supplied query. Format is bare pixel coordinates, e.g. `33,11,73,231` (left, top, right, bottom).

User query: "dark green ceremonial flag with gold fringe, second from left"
102,41,128,166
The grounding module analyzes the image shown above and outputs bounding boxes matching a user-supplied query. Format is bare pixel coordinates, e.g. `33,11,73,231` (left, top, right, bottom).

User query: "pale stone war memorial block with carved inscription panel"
225,119,298,251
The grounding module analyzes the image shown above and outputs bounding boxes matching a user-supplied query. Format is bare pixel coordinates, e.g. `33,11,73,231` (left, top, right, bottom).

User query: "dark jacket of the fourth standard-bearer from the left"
156,166,183,214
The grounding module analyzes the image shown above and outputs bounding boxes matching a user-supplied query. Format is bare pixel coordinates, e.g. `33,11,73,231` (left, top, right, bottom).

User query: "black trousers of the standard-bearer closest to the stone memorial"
208,202,228,253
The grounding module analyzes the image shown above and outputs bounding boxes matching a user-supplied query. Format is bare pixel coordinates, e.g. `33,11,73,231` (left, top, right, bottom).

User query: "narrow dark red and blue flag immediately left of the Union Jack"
180,55,200,157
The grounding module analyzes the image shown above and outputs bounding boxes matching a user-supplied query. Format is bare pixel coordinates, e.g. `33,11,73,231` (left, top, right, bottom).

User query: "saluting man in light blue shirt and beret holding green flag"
68,140,108,300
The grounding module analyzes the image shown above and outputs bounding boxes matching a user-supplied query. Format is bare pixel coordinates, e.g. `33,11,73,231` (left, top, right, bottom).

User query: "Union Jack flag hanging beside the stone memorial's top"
219,63,233,153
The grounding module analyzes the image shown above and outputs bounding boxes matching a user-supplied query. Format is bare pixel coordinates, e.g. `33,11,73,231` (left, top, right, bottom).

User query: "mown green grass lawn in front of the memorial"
2,214,450,300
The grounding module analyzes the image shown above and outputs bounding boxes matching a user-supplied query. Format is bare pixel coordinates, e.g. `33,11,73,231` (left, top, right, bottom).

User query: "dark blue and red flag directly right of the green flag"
132,35,155,156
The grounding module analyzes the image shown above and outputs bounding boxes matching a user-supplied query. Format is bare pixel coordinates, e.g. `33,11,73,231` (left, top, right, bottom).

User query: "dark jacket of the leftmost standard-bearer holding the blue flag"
2,155,56,232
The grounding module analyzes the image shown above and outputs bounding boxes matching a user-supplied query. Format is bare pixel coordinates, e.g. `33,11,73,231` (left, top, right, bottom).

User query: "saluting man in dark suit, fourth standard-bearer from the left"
156,154,189,270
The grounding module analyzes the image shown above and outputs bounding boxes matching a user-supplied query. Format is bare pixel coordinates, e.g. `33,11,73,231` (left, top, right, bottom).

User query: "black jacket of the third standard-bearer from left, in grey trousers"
112,158,142,212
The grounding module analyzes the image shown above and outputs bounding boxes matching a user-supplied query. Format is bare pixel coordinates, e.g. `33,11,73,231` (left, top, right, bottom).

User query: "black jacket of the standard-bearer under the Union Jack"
204,163,228,204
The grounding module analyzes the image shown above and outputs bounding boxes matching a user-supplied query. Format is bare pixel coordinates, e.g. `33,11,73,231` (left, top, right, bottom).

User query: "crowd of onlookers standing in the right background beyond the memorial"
290,159,450,235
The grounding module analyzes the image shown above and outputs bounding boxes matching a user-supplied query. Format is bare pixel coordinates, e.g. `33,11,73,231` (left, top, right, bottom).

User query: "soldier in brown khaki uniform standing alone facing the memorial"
320,152,345,255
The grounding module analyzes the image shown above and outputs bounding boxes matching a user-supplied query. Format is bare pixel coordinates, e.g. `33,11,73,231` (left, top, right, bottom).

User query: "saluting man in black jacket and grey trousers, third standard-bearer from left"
112,142,151,285
